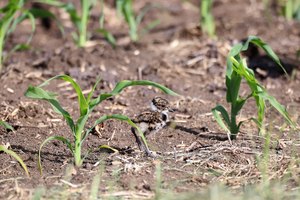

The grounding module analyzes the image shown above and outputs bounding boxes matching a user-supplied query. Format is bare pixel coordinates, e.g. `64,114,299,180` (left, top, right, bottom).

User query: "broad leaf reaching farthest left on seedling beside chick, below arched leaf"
24,86,75,133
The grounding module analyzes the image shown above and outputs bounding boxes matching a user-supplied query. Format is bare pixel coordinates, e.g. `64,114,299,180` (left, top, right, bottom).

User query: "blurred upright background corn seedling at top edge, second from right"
200,0,215,37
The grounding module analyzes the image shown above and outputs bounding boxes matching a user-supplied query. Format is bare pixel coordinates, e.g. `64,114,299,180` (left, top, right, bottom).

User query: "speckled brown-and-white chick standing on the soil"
131,97,173,157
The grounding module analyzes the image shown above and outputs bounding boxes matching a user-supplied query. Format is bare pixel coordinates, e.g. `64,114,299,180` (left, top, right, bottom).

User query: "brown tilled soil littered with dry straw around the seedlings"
0,0,300,199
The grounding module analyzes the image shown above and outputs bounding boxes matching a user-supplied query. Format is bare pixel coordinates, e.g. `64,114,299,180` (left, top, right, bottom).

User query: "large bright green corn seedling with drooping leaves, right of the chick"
212,36,295,139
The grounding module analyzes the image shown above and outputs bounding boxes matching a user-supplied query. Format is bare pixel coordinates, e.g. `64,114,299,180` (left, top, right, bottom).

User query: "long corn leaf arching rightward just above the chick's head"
89,80,178,110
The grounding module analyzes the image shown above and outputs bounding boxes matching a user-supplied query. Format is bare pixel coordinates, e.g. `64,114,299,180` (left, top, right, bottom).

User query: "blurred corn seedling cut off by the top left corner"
0,0,35,71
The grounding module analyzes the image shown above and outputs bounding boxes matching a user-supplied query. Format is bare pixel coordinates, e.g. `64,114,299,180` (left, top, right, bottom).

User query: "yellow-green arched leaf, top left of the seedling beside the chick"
38,75,88,116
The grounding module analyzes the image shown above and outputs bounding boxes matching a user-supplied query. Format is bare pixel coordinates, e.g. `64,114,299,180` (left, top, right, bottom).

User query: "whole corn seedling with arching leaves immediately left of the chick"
25,75,177,172
